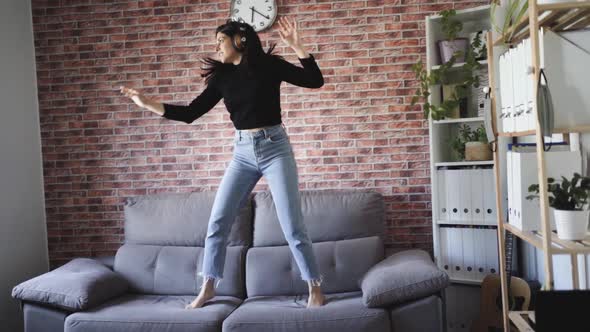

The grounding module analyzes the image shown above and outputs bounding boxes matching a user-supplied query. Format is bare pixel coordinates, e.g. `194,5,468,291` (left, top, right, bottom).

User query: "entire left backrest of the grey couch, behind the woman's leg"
114,192,252,298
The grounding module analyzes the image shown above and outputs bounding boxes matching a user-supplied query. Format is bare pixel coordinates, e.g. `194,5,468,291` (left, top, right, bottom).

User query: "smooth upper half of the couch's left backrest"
124,191,252,247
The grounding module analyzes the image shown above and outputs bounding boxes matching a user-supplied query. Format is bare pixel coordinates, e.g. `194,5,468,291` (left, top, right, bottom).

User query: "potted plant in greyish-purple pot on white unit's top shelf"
438,9,469,63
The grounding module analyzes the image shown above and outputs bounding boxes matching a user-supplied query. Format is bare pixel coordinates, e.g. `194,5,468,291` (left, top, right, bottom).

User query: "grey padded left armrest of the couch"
12,258,129,311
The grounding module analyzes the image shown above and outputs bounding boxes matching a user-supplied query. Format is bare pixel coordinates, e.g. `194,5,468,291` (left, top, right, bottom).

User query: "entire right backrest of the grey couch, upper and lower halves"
246,190,385,297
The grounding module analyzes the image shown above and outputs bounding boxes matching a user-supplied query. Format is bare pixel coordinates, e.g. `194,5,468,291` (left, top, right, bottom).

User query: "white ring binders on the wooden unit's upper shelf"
497,28,590,133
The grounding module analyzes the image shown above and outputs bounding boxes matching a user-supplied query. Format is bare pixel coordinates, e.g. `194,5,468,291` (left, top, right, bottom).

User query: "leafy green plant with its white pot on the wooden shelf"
526,173,590,240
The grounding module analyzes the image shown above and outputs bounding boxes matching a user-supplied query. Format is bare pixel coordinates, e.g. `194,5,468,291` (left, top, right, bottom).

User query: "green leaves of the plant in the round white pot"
526,173,590,211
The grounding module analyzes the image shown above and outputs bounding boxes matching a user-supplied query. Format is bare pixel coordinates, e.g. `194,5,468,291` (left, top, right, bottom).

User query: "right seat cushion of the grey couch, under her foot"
223,292,390,332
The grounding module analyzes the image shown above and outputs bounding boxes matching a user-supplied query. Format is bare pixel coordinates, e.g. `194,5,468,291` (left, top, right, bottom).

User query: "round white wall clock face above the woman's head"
230,0,277,31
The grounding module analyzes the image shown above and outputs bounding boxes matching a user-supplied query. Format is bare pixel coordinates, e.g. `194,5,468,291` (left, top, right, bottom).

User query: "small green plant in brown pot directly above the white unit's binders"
451,124,492,161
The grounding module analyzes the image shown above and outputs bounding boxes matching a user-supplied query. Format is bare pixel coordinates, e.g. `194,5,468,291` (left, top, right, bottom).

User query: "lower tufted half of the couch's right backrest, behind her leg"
246,236,385,297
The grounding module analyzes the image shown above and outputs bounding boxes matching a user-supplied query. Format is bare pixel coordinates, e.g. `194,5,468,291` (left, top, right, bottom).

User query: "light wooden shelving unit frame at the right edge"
487,0,590,331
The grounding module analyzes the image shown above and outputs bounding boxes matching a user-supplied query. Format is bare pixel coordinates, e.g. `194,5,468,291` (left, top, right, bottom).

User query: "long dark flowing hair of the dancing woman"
201,19,282,83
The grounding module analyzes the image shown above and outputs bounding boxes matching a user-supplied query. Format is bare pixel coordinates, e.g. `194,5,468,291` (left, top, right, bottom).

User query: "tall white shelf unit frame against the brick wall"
426,5,498,285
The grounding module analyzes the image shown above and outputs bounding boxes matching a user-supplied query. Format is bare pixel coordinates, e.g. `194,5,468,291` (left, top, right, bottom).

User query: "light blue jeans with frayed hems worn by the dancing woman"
198,124,323,287
